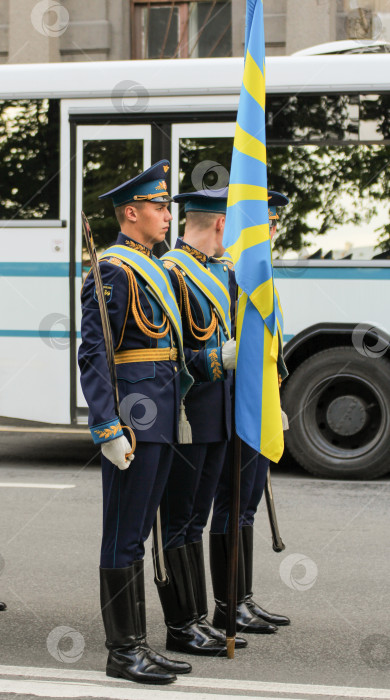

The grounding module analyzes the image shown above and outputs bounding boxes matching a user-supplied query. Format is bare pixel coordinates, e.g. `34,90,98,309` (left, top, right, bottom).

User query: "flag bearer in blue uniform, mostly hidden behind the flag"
210,191,290,634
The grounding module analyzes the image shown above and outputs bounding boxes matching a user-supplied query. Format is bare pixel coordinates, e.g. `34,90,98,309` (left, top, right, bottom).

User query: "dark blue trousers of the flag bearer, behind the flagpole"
210,442,269,534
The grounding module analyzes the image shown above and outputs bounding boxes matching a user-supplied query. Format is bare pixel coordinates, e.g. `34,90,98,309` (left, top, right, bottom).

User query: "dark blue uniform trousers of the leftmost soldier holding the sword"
100,442,173,569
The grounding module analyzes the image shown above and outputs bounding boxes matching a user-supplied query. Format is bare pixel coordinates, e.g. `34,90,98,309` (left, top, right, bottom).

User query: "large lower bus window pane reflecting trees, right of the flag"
268,144,390,260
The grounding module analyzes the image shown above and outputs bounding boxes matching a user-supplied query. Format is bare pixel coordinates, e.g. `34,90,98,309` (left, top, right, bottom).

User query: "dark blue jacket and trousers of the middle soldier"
161,239,231,549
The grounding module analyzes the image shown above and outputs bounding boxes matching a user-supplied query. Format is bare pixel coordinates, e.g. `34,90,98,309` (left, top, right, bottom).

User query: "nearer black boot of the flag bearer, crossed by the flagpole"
210,532,278,634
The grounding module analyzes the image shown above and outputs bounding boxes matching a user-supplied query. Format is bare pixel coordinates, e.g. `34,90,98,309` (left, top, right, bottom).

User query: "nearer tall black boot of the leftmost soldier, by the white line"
100,562,176,684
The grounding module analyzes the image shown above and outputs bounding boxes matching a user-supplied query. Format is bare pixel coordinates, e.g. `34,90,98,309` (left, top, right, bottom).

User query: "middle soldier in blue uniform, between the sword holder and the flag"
153,191,246,656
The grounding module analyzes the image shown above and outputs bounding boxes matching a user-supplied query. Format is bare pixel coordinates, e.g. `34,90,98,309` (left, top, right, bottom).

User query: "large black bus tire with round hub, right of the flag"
282,347,390,479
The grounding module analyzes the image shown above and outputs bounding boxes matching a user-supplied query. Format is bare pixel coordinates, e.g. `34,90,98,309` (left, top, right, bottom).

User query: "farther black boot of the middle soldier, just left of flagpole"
186,540,248,649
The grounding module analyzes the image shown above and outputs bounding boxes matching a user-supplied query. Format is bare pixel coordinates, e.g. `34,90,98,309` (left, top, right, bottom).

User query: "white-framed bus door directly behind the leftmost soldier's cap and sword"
71,124,151,423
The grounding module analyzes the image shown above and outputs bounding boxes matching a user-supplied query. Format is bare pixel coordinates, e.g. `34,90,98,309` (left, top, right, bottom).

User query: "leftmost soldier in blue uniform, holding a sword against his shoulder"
79,160,193,683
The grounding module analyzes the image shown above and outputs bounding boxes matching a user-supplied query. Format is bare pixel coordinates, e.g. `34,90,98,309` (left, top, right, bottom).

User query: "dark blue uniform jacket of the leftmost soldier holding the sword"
79,233,180,443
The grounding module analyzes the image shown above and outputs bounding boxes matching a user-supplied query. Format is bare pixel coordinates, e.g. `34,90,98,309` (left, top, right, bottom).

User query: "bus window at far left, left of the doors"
0,99,60,220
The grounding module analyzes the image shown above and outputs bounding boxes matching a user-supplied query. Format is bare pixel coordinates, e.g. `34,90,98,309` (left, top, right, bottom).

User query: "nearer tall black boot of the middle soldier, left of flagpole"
157,546,227,656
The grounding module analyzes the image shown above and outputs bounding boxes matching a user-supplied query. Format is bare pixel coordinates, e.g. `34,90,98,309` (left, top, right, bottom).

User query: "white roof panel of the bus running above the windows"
0,54,390,98
